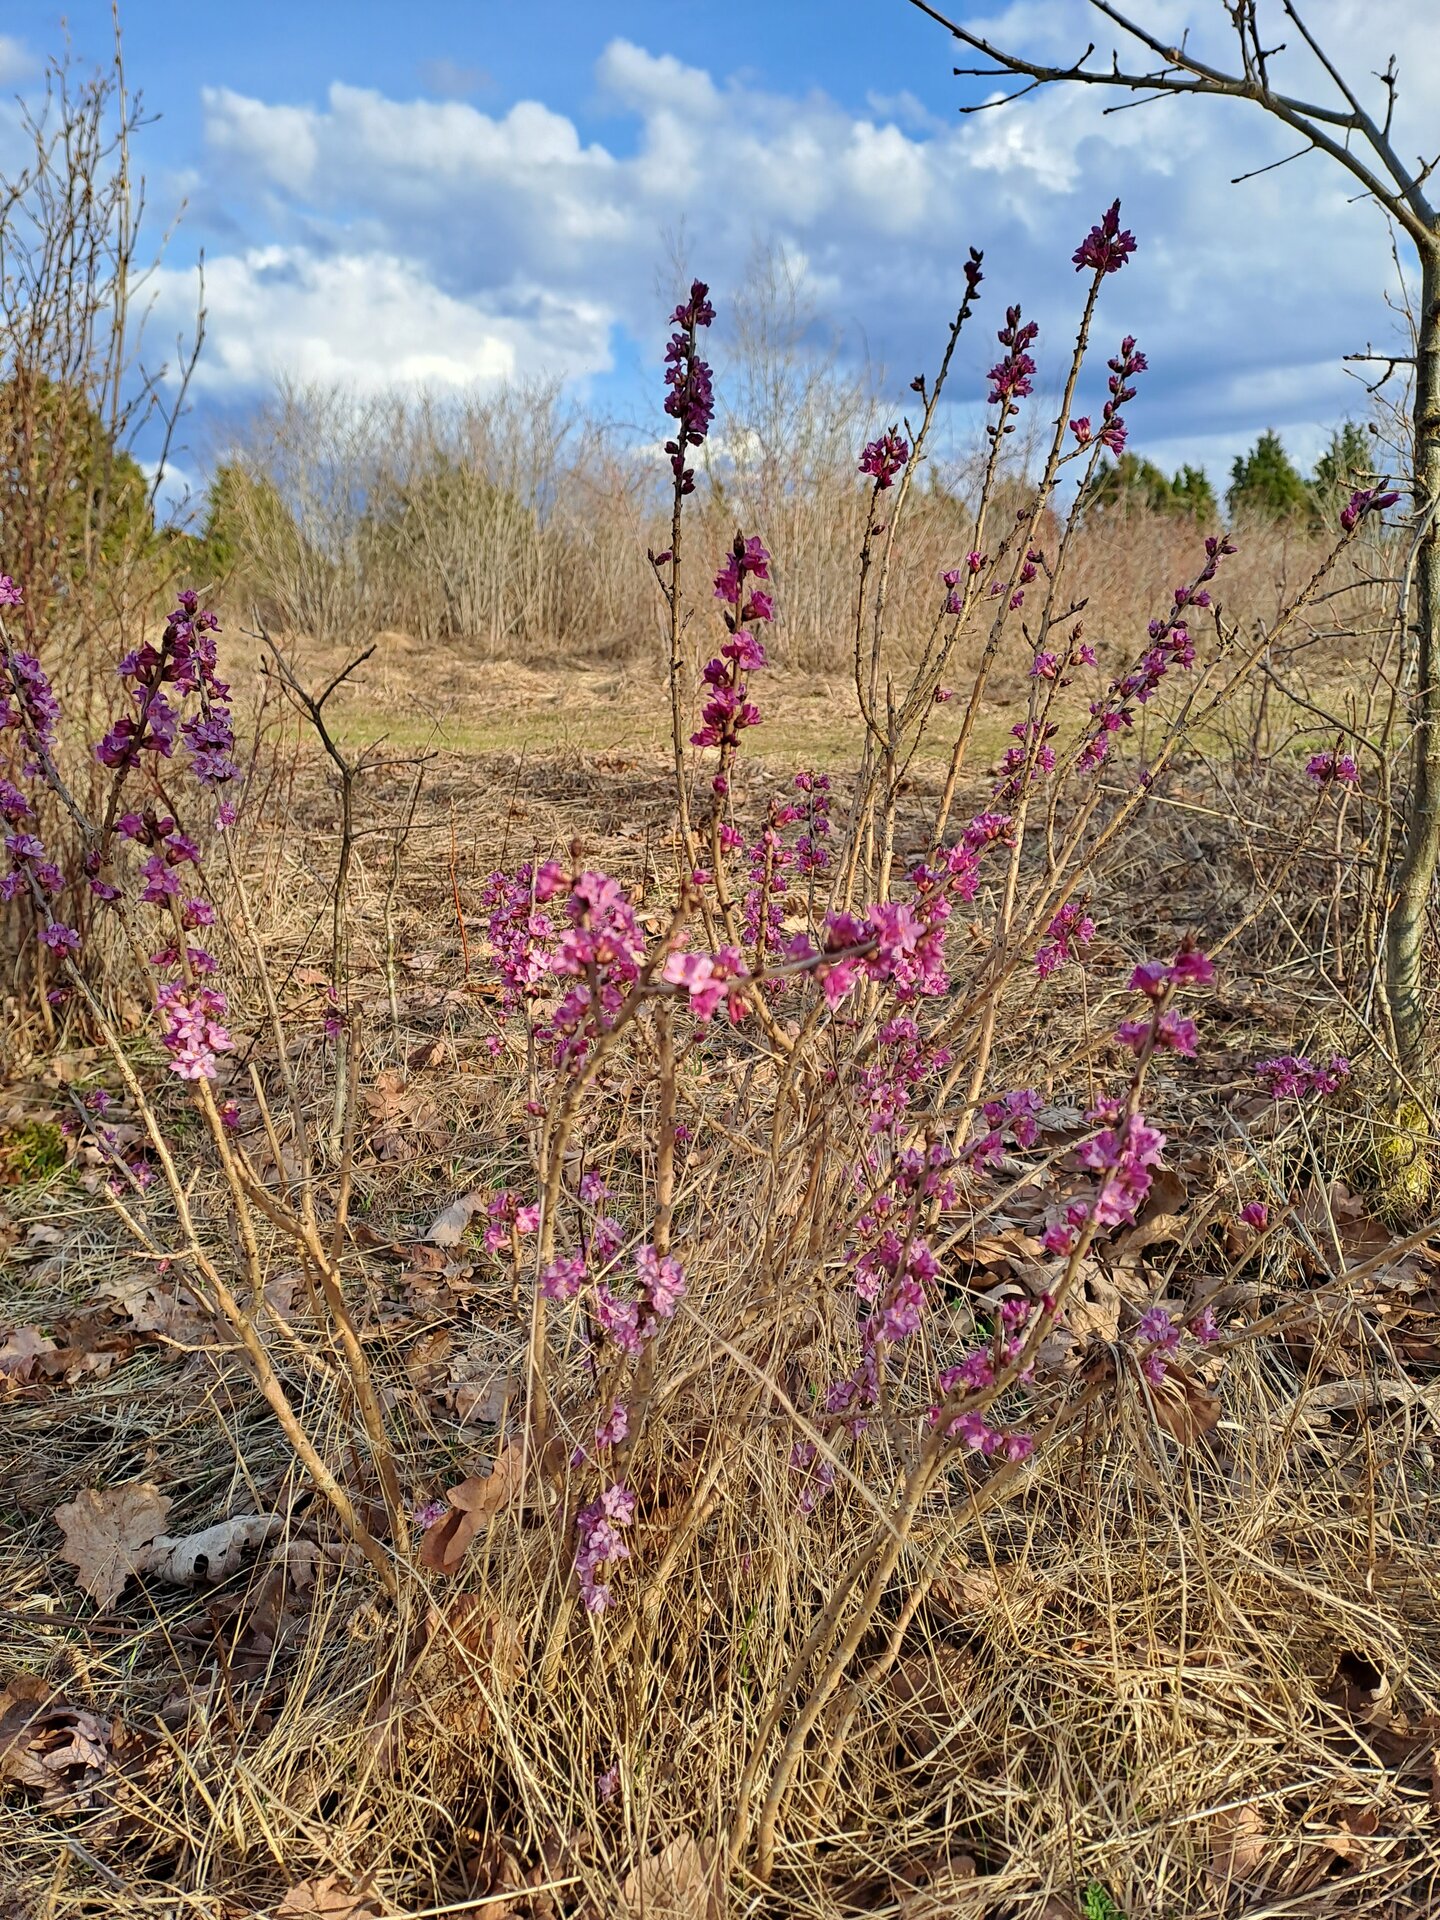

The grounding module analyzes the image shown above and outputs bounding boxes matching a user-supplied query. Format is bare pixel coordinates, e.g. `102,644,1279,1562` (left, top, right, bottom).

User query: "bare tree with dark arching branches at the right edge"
908,0,1440,1173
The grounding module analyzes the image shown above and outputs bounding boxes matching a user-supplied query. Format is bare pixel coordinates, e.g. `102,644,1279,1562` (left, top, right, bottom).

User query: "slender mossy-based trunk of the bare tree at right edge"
1384,232,1440,1202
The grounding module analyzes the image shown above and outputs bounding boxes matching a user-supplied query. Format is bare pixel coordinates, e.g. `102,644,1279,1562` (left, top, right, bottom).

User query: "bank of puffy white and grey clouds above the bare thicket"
174,0,1440,472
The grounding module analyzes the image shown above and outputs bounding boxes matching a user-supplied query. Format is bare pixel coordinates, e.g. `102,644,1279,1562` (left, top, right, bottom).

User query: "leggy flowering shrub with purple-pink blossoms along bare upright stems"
0,191,1386,1874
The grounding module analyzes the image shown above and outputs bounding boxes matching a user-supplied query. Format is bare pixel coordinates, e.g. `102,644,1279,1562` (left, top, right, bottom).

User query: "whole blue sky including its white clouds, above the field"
0,0,1440,510
